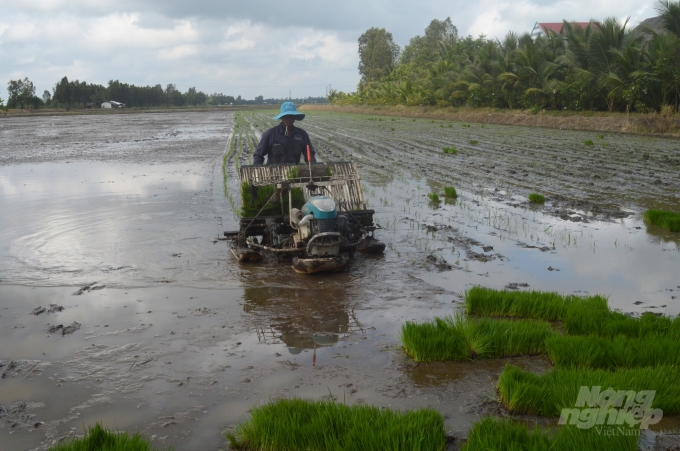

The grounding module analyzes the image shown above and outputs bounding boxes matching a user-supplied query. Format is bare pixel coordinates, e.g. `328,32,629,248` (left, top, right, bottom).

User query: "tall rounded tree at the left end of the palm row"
359,27,400,83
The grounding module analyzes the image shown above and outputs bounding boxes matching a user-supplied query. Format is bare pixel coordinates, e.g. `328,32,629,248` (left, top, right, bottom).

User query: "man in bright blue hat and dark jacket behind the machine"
253,102,316,164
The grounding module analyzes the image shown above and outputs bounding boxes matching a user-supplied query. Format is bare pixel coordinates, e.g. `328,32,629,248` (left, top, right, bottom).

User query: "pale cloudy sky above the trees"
0,0,656,100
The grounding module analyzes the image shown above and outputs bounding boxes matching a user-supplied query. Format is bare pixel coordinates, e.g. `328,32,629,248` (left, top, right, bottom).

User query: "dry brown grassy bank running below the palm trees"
303,105,680,138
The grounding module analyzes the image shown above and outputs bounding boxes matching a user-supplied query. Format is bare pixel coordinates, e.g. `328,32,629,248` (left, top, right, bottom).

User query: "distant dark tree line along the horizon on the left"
0,77,328,109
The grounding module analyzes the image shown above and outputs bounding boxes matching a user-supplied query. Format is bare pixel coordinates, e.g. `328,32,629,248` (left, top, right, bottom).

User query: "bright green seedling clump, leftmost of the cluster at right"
400,315,553,362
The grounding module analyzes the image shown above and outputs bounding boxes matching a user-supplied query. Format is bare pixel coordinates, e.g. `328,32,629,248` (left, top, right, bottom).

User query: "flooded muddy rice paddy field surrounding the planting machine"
0,111,680,450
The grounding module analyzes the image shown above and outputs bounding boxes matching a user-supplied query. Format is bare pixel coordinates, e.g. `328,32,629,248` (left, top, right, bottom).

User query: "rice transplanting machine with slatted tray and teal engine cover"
224,162,385,274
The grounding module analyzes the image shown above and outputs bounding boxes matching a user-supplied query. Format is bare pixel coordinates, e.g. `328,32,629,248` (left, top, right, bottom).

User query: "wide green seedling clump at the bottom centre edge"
227,399,446,451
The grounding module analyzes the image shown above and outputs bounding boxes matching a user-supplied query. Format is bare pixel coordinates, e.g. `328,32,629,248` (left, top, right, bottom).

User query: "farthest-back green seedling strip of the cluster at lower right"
465,287,609,321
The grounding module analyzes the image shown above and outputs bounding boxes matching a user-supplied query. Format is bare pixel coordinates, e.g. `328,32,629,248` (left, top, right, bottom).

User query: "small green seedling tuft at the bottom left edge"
49,423,170,451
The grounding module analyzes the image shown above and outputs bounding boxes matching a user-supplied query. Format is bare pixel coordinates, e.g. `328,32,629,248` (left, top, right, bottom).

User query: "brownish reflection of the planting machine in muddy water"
243,288,364,364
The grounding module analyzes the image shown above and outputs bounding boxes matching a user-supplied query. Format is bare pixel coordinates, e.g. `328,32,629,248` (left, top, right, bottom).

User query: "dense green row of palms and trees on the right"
329,1,680,112
